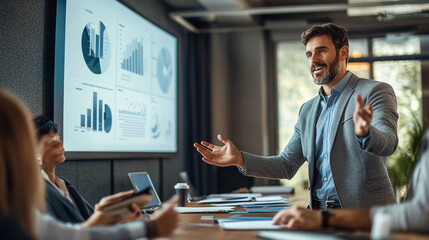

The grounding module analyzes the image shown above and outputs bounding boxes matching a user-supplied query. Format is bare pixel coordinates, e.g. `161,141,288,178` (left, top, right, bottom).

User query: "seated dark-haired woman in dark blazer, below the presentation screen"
34,116,94,223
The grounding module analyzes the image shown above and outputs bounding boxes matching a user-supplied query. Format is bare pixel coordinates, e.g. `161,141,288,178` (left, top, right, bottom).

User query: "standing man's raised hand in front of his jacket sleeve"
353,95,372,138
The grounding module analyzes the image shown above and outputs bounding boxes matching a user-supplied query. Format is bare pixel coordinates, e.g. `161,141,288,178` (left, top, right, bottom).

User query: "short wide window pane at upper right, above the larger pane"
372,34,420,57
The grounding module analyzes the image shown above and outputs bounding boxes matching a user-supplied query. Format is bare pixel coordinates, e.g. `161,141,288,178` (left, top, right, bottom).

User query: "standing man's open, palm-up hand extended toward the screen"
194,134,244,168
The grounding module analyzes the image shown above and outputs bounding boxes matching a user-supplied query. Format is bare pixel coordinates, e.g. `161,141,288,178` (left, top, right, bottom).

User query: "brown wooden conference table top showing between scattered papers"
169,193,429,240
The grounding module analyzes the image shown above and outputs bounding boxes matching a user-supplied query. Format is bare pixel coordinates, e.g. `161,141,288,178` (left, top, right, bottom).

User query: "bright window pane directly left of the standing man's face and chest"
276,41,319,189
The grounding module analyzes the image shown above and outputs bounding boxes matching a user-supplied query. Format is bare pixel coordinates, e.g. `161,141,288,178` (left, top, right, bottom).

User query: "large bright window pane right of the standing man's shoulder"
374,61,423,147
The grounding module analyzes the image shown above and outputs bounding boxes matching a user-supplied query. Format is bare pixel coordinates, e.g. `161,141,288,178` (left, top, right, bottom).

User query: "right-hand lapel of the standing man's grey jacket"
331,74,359,148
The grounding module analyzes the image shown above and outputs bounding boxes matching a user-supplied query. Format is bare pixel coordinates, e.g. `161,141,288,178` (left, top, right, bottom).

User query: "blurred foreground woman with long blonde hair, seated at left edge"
0,90,178,240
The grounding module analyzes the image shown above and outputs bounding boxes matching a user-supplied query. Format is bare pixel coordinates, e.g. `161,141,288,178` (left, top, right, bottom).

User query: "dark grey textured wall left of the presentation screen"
0,0,45,115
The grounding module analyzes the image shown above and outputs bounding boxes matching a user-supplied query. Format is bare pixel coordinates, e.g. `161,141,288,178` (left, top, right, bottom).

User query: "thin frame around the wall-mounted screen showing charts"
53,0,180,160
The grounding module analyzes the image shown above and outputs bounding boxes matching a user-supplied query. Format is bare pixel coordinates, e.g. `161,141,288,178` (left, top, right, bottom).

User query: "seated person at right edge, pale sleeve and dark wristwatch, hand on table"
273,131,429,233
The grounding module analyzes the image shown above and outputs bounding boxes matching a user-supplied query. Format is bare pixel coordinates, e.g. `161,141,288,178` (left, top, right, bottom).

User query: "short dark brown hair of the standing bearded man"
301,23,349,52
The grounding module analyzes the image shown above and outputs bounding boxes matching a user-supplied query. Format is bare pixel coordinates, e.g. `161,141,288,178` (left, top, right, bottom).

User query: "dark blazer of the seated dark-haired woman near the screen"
45,179,94,223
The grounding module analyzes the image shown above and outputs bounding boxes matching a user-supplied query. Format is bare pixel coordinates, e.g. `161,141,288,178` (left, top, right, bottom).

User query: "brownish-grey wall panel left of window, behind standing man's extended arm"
211,32,266,192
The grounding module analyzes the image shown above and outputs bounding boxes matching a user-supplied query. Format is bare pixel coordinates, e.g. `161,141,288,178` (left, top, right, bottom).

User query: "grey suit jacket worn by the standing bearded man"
240,74,398,208
